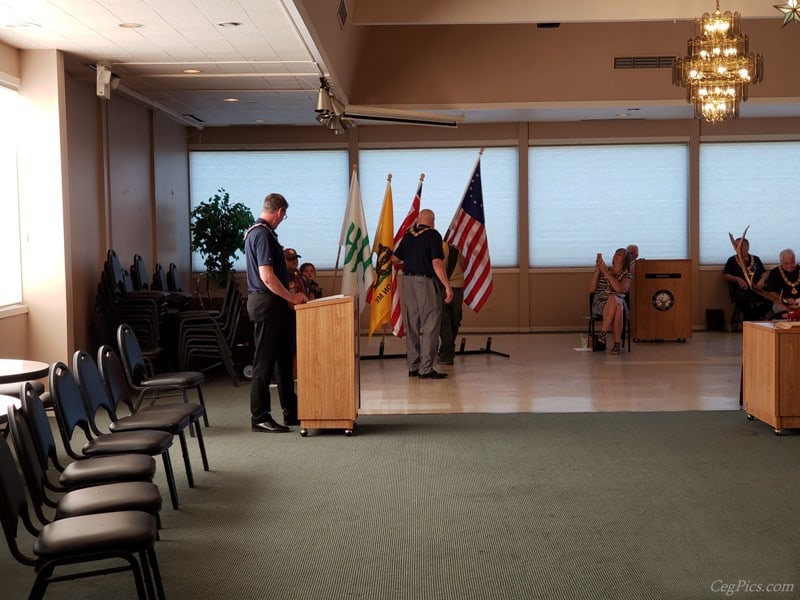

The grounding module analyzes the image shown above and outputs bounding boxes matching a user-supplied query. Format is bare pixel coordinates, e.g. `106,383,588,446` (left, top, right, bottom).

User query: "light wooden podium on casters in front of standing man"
294,296,361,436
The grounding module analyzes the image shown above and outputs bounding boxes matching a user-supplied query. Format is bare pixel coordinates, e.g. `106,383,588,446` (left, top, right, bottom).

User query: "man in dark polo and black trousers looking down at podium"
245,194,307,433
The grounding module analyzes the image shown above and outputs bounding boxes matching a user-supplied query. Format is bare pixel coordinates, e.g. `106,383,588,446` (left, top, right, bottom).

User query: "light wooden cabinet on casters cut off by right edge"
742,321,800,433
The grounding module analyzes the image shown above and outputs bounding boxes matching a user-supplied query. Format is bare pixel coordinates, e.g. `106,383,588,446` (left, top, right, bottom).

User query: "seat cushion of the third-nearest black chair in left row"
58,454,156,489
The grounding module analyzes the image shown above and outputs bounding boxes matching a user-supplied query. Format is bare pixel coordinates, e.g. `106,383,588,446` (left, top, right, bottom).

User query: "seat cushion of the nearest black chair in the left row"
33,511,156,558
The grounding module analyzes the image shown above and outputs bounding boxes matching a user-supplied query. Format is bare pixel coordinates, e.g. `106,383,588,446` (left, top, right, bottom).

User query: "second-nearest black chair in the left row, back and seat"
8,407,161,525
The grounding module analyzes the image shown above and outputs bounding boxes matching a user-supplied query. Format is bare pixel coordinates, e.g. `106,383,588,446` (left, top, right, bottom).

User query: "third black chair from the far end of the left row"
72,350,205,487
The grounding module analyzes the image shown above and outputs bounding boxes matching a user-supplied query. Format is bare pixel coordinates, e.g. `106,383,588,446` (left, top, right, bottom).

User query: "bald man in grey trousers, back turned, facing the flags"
392,208,453,379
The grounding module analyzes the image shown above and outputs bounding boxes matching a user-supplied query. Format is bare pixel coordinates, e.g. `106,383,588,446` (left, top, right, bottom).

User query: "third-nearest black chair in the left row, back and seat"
19,384,156,492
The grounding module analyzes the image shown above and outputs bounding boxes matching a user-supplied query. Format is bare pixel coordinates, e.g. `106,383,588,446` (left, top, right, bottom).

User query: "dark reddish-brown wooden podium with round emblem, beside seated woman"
630,259,692,342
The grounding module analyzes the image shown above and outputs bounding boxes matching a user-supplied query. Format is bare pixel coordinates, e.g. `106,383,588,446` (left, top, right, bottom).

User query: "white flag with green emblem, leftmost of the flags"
339,170,375,310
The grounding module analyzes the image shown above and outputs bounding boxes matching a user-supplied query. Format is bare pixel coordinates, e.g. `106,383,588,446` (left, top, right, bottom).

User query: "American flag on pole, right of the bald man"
444,151,492,312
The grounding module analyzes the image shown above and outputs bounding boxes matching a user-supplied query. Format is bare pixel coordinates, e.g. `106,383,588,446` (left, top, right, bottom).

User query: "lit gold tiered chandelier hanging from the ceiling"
672,0,764,123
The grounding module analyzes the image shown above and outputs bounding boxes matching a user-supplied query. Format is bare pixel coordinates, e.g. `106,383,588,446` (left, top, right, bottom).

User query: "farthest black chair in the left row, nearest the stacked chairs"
117,323,208,427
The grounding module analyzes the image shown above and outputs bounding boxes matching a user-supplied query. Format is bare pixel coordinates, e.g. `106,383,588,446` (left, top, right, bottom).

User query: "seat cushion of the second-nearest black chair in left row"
56,481,161,519
